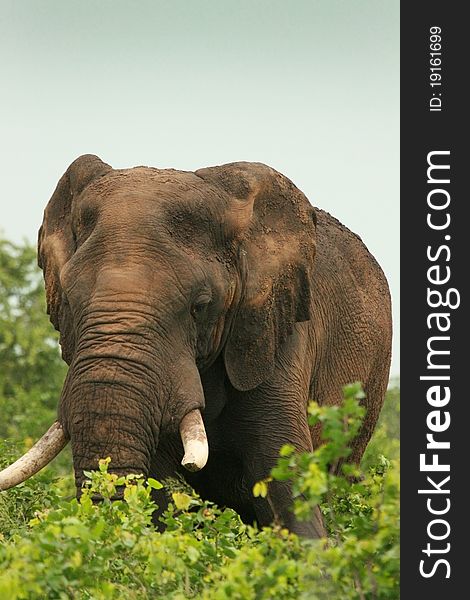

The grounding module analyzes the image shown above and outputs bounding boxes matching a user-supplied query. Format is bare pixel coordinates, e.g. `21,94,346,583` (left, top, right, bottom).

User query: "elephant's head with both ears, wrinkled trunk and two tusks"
0,155,315,496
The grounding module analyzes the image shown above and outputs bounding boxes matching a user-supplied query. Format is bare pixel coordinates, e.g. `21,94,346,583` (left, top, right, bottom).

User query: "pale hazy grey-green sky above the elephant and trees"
0,0,399,374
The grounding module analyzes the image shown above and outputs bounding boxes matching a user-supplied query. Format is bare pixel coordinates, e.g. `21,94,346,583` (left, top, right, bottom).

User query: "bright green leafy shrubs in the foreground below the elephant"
0,386,399,600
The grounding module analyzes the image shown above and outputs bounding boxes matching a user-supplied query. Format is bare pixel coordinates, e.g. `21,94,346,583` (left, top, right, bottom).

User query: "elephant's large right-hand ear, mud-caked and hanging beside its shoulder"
196,162,316,391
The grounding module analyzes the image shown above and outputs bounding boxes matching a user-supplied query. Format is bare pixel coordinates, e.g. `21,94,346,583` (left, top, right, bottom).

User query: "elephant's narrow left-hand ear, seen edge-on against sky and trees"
38,154,111,364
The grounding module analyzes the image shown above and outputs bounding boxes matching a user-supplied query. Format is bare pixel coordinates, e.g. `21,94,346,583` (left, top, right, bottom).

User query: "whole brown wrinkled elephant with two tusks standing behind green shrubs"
0,155,392,538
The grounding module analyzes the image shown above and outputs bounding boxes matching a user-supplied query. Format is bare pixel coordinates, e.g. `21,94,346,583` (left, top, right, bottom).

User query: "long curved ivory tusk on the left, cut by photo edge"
0,421,68,491
